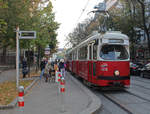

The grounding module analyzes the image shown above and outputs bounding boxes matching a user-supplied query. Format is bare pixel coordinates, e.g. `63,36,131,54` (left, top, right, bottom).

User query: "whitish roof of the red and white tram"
68,31,129,53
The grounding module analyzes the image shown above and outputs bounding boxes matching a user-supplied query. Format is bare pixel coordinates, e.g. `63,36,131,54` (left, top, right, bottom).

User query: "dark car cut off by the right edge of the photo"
140,63,150,77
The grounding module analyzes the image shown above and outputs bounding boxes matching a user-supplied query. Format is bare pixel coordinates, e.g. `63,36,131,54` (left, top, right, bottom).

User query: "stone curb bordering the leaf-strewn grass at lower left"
0,79,39,110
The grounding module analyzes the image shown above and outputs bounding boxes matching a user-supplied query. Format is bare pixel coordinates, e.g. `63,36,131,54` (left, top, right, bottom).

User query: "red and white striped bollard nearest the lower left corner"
18,86,24,111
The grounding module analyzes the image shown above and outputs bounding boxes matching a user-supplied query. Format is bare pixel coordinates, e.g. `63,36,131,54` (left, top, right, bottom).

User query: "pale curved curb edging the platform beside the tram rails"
70,72,102,114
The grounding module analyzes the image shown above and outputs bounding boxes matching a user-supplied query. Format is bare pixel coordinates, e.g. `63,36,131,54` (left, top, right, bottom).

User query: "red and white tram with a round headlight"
66,31,130,87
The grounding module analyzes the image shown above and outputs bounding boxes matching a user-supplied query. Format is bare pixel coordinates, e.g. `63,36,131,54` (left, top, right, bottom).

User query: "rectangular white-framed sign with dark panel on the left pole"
19,31,36,39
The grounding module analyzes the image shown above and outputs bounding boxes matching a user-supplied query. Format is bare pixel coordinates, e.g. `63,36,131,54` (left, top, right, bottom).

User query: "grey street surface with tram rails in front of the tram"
92,76,150,114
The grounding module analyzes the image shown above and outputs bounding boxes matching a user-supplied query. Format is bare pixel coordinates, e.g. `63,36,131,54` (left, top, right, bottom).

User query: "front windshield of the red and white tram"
100,45,129,60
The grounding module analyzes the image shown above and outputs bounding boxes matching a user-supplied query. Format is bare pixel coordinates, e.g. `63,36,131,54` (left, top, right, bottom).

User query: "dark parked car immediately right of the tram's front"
130,62,143,75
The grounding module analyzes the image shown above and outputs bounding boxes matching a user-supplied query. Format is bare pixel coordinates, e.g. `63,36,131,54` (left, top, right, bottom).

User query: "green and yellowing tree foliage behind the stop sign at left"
0,0,59,54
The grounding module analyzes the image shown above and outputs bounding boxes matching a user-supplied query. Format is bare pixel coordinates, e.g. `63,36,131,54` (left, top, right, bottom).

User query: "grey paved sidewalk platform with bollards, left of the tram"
0,73,101,114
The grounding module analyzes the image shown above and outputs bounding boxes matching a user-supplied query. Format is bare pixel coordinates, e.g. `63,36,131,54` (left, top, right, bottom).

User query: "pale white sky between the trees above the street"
52,0,103,48
